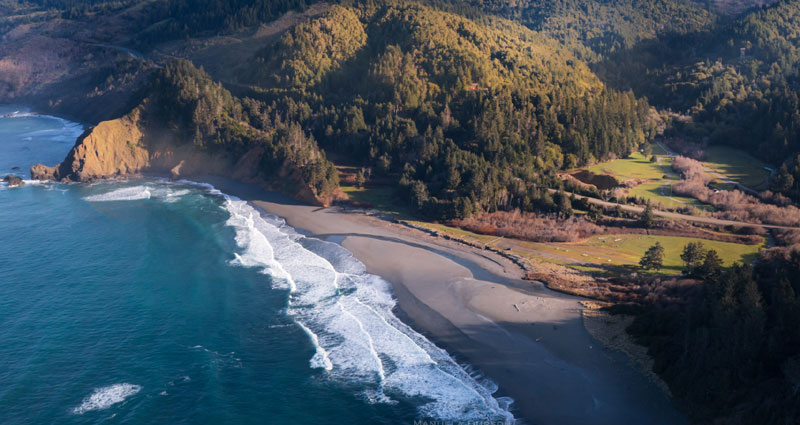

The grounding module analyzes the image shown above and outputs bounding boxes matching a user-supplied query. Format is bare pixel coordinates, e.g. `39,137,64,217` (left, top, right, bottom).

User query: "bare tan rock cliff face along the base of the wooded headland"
30,106,332,206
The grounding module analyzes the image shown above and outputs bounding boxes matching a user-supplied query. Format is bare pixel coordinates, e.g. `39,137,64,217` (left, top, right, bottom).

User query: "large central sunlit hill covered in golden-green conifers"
233,1,655,218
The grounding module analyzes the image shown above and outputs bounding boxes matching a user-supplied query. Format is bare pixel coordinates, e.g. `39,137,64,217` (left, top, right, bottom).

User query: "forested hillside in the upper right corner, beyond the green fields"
597,0,800,166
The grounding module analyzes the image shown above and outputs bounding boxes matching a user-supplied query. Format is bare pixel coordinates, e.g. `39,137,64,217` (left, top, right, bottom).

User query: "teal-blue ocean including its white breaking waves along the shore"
0,106,512,425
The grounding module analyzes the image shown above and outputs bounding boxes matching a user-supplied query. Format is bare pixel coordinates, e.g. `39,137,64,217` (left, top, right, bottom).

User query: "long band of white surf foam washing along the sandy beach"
216,191,513,423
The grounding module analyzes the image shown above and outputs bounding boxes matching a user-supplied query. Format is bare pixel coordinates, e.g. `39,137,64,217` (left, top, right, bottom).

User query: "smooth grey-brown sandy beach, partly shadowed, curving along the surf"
202,177,686,425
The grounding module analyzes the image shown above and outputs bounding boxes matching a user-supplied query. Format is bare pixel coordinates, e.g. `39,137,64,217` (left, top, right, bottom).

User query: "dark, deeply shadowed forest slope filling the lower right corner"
631,252,800,424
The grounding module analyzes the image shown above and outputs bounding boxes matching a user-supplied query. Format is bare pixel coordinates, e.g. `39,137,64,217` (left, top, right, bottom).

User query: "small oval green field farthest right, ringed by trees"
703,146,770,190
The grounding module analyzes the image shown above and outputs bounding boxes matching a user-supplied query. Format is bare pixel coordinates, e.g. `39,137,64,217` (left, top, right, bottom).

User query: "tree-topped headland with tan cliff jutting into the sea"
31,60,338,205
